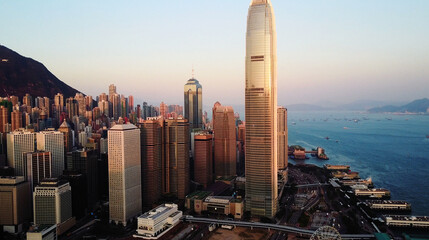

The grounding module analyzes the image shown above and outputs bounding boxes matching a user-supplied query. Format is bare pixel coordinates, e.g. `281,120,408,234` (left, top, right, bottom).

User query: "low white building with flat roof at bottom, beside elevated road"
134,204,182,239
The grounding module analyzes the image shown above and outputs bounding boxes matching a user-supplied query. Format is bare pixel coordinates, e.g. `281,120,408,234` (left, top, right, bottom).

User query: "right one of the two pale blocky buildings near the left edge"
36,131,64,178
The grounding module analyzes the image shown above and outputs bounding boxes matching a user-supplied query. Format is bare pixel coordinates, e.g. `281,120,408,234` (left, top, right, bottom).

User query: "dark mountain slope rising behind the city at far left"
0,45,79,98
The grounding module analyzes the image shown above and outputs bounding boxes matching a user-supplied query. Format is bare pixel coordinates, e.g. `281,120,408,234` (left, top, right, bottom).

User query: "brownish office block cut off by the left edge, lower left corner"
0,176,31,233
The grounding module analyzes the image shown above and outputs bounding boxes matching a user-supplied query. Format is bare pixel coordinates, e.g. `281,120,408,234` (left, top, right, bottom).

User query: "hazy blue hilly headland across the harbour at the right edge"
368,98,429,113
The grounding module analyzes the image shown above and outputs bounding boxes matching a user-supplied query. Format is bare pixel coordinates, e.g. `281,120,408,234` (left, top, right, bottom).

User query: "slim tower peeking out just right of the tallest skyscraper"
277,107,288,169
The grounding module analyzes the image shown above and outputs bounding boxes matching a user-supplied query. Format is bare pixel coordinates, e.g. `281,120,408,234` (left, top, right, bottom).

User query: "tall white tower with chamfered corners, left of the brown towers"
108,124,142,226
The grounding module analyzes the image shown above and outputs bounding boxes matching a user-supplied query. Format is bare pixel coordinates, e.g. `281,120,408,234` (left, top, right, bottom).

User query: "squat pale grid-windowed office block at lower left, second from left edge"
33,178,75,235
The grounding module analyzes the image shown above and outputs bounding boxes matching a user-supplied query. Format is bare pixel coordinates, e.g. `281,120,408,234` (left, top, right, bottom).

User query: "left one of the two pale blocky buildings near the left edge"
7,130,35,176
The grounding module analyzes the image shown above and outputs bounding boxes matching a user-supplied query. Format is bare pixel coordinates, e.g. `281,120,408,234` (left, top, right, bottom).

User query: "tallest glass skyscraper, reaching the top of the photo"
245,0,278,217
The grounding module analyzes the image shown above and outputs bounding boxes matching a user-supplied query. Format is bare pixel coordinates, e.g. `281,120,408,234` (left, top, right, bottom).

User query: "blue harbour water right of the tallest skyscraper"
288,111,429,216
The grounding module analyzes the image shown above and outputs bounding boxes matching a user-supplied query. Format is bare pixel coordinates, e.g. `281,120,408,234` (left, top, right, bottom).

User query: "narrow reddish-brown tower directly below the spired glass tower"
194,133,213,188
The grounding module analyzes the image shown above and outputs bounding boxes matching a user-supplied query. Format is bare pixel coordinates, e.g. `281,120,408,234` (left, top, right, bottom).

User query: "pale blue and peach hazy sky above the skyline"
0,0,429,106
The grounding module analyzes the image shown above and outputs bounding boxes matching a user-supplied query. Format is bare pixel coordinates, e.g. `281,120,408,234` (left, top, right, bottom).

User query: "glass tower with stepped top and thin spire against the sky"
185,78,203,129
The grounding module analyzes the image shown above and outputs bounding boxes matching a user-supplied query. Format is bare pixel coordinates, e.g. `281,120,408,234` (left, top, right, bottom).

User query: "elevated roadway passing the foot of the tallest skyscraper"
182,215,374,240
